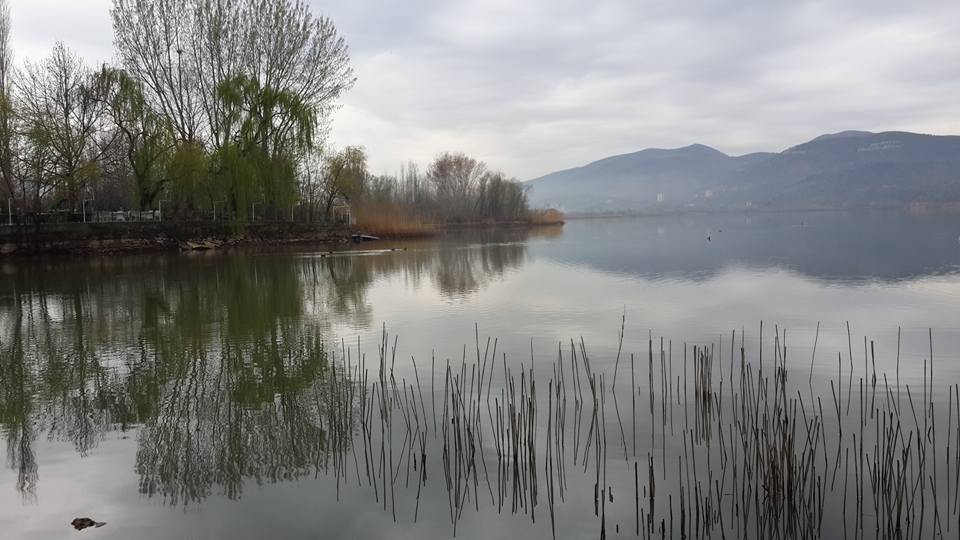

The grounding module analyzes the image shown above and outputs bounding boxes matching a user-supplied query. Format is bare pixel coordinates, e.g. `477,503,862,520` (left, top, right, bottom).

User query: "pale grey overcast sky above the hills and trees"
9,0,960,179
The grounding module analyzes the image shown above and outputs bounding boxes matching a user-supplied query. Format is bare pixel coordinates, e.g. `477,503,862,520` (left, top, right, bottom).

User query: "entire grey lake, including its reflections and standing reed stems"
0,211,960,539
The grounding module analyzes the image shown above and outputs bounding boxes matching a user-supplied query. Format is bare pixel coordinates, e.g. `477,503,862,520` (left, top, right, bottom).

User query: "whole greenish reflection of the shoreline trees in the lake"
0,230,526,504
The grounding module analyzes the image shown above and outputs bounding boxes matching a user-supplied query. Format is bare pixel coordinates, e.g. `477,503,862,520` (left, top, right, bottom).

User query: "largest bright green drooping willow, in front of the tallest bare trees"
214,76,318,218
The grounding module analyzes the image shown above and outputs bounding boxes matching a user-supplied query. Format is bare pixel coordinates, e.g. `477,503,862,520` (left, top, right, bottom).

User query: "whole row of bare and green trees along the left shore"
0,0,548,228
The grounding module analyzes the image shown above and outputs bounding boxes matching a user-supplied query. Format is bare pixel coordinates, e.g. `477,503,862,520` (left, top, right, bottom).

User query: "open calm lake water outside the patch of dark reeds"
0,213,960,538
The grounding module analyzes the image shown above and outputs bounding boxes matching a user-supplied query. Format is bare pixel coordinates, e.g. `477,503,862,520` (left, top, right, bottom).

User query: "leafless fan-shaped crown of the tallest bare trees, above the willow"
111,0,354,150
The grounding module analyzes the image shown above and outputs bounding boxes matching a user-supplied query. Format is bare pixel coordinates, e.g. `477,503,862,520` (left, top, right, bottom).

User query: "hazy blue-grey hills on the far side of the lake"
529,131,960,213
